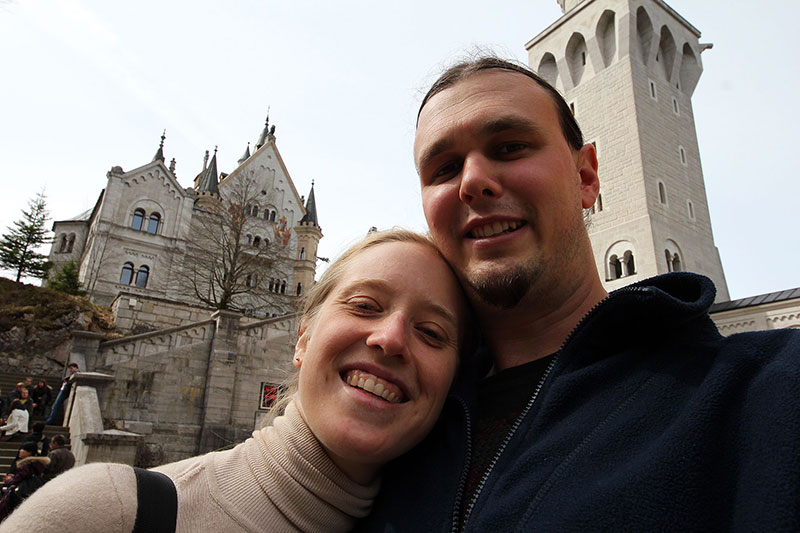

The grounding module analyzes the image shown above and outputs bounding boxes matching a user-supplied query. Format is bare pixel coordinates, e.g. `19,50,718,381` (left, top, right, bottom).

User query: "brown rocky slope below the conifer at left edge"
0,278,114,377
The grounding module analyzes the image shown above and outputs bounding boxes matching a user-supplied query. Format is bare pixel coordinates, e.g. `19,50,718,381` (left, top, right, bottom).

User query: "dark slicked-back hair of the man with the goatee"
417,56,583,150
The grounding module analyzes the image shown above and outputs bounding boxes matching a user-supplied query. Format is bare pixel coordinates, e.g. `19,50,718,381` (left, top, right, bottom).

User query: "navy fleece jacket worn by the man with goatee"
359,273,800,531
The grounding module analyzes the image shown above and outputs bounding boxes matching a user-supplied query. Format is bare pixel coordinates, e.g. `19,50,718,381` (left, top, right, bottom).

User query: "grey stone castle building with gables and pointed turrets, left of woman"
50,118,322,326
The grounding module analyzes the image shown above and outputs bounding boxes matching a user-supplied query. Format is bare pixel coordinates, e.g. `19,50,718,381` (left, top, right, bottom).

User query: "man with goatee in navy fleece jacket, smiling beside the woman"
361,58,800,531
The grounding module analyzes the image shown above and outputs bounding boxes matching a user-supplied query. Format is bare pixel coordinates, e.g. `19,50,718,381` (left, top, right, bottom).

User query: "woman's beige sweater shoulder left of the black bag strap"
3,463,137,533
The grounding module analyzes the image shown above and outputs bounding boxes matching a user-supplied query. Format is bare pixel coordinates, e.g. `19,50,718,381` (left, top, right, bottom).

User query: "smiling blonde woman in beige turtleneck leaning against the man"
3,231,471,533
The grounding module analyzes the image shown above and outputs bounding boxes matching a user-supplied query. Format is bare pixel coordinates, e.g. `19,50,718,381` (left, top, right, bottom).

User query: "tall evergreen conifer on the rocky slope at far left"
0,193,51,281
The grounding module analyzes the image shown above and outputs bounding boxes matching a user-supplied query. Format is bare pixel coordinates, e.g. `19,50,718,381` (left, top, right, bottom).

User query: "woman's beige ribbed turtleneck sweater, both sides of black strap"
0,403,379,533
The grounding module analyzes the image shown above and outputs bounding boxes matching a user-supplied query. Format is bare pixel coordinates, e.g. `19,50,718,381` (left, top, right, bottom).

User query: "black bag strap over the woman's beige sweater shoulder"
133,467,178,533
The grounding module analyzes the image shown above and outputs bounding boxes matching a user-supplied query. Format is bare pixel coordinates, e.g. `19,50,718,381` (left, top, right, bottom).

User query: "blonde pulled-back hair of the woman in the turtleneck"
267,228,477,424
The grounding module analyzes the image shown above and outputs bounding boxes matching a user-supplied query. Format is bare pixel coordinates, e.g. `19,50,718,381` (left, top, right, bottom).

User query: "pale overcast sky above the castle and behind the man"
0,0,800,298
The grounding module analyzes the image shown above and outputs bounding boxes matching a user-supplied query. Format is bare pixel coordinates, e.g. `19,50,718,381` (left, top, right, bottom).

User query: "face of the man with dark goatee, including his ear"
414,70,599,307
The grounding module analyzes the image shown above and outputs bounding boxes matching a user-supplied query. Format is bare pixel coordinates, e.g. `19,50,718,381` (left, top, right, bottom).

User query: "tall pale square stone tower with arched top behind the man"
525,0,729,301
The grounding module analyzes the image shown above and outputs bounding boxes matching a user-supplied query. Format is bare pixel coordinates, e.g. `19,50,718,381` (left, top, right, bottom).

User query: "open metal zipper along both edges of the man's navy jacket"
451,287,649,533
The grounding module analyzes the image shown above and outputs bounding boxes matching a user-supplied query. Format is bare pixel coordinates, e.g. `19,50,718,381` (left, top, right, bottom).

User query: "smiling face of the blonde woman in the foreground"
295,242,465,481
